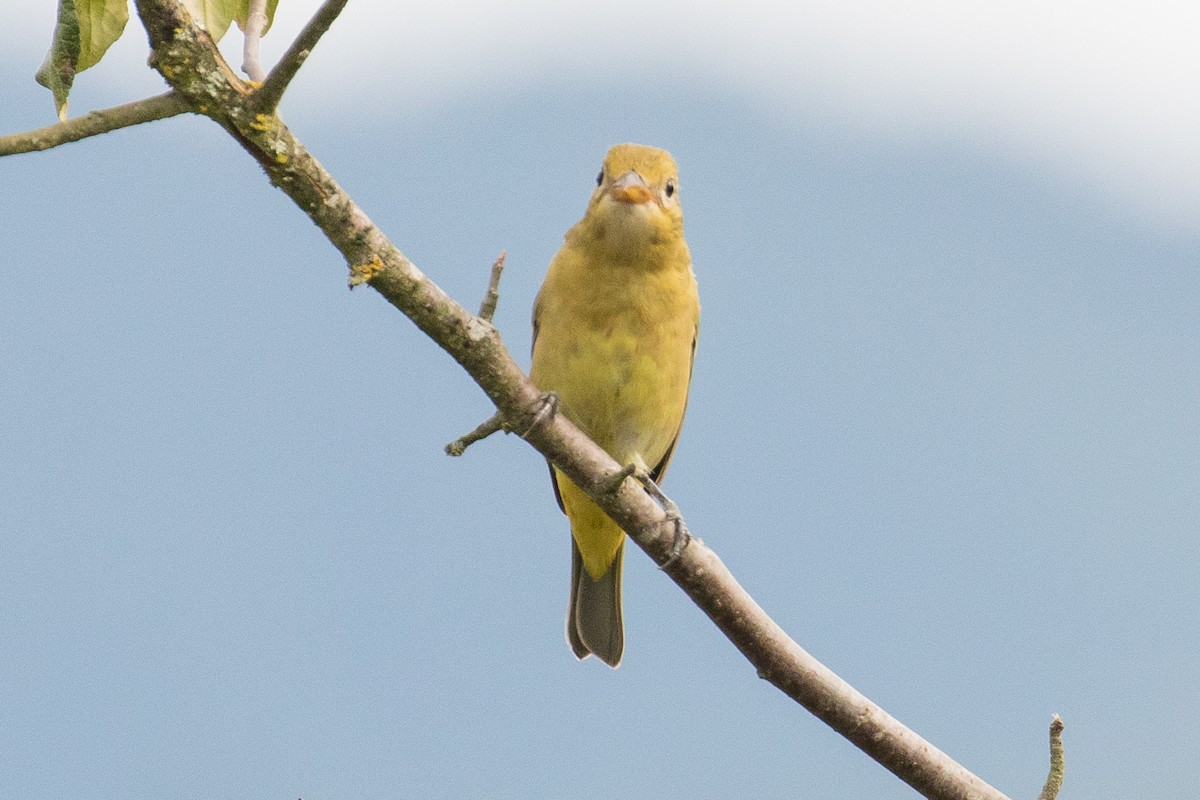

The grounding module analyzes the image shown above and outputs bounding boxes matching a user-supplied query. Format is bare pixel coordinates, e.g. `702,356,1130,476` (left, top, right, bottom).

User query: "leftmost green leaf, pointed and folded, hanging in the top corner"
35,0,130,120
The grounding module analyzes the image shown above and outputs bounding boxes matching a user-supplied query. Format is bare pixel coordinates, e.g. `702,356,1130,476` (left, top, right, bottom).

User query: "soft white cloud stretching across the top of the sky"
9,0,1200,230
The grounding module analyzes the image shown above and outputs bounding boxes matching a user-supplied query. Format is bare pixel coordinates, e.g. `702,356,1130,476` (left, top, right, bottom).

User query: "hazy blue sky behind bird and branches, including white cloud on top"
0,2,1200,800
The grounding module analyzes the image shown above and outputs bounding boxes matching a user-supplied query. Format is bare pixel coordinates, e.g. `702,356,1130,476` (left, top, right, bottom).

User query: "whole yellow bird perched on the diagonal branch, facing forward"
530,144,700,667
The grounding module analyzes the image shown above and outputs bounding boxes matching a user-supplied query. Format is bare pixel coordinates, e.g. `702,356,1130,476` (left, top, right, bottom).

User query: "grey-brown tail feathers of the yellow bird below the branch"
566,536,625,668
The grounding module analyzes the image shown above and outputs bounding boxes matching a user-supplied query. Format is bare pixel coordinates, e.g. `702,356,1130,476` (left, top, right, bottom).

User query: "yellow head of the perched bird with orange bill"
581,144,683,256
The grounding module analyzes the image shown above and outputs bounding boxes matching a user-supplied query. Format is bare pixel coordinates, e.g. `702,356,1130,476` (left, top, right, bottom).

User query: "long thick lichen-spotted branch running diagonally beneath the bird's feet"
126,0,1036,800
